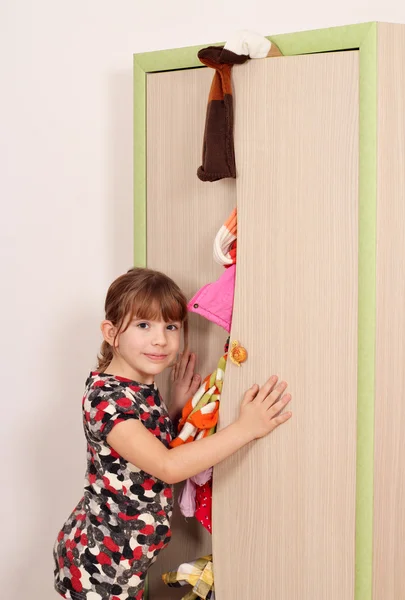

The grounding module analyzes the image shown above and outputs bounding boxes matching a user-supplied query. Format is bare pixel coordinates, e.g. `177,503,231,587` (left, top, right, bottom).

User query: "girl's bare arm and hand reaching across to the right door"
107,376,291,484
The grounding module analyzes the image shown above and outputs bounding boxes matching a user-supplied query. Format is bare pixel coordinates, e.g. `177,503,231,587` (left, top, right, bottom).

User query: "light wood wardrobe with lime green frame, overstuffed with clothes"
134,23,405,600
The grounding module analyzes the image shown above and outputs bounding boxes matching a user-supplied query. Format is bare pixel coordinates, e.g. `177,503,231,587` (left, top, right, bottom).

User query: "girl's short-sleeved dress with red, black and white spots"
54,372,175,600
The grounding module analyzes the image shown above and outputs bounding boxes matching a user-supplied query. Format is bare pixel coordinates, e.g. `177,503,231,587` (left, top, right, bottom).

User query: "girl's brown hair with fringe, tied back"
97,267,188,372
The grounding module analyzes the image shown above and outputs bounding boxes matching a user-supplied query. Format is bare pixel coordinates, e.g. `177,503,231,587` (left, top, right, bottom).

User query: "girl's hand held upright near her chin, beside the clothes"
170,351,201,411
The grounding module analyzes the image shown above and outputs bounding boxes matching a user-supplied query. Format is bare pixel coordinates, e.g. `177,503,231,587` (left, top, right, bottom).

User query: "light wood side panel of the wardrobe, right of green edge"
373,23,405,600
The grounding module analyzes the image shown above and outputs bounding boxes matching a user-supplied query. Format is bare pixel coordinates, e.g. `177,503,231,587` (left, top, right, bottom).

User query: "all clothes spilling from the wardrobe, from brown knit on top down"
162,31,281,600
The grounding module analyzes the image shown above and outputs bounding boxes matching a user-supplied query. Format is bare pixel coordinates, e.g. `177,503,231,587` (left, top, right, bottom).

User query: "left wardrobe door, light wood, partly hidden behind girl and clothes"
147,69,236,600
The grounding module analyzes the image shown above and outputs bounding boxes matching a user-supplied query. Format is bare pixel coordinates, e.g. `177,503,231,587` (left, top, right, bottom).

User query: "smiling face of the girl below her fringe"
105,317,182,383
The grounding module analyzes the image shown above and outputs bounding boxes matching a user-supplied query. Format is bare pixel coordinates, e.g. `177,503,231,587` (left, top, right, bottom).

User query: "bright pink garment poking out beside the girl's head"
187,265,236,333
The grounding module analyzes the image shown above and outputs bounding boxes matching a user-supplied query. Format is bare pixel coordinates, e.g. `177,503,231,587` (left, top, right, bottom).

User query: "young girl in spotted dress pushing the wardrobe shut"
54,268,291,600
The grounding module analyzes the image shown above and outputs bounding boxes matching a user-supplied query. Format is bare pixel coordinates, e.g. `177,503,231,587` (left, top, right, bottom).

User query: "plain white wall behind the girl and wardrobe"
0,0,405,600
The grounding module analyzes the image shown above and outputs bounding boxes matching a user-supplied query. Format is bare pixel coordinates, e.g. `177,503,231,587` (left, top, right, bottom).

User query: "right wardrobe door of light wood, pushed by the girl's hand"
213,51,359,600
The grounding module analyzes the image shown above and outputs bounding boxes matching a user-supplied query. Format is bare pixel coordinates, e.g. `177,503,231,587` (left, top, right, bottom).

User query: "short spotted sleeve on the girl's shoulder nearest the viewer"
83,388,140,441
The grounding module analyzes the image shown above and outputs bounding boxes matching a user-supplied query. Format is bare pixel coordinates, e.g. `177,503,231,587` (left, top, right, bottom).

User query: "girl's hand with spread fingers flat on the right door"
237,375,291,440
